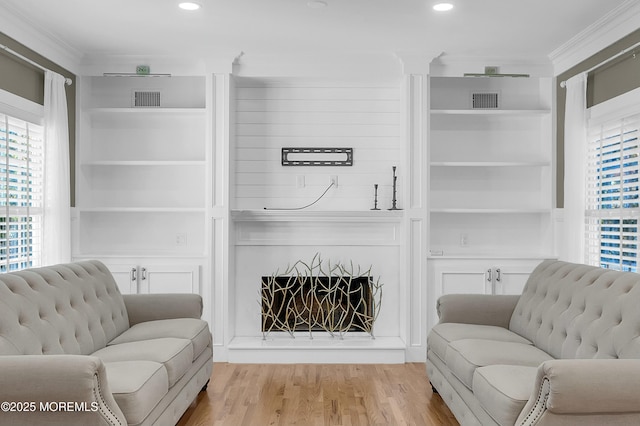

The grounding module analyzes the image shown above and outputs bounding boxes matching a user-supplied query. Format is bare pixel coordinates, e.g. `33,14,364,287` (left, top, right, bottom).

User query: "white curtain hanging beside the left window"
42,71,71,266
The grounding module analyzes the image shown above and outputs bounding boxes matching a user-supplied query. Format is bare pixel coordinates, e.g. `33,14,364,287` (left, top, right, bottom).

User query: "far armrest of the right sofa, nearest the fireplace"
436,294,520,328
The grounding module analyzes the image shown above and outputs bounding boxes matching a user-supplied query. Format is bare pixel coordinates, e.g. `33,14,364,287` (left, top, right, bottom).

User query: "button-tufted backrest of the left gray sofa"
0,261,129,355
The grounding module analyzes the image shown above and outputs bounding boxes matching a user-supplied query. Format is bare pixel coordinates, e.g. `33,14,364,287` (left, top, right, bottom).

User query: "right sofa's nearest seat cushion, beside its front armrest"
473,365,538,426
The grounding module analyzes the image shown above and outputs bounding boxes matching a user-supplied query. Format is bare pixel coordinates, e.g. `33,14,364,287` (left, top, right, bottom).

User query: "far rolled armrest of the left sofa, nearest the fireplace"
123,293,202,326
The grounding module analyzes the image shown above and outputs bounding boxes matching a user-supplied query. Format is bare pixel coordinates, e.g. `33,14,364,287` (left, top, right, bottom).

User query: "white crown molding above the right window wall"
549,0,640,75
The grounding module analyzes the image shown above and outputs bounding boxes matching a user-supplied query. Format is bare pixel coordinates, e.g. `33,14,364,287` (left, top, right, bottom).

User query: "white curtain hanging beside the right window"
561,73,587,263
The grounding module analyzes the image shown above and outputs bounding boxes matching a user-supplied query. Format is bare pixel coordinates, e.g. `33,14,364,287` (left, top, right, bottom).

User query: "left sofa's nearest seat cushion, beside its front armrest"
105,361,169,425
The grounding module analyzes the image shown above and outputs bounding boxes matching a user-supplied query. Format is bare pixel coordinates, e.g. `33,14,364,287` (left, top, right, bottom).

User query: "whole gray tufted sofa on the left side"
0,261,213,426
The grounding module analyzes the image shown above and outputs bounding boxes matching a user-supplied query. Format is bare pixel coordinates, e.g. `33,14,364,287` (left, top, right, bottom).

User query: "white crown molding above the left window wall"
0,4,82,74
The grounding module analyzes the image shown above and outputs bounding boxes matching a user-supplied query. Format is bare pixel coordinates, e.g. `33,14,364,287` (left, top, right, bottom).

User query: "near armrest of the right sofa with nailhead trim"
516,359,640,425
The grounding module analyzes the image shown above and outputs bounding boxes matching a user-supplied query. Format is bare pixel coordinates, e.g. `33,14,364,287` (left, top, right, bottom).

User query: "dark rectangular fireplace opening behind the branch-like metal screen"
262,276,375,336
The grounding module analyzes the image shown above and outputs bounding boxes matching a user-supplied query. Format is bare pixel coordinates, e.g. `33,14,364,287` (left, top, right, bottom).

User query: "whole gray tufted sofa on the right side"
427,260,640,426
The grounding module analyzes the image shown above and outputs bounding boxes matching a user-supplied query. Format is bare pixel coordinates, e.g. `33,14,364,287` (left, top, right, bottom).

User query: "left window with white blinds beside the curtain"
0,113,44,272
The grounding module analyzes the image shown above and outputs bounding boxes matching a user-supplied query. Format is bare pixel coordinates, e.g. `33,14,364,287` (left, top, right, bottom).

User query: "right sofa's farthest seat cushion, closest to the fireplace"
427,323,531,361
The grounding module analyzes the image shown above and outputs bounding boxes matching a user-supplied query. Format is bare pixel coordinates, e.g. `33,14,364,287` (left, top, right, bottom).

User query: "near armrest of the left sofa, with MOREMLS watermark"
0,355,127,426
